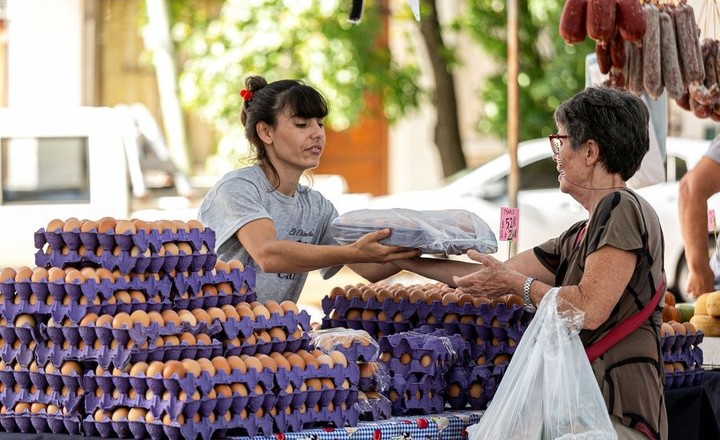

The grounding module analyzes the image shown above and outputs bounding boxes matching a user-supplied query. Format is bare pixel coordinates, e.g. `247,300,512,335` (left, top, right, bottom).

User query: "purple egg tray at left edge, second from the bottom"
0,369,84,402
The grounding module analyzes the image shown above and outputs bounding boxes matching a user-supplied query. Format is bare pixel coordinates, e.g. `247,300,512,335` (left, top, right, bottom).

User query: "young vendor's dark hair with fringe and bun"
240,76,328,183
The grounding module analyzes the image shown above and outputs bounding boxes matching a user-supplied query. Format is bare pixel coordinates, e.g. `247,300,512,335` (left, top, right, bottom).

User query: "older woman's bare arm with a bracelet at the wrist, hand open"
456,246,637,330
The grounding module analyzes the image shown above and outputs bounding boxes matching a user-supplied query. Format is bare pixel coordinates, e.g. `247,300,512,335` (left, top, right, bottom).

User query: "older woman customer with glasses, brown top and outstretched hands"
393,87,667,439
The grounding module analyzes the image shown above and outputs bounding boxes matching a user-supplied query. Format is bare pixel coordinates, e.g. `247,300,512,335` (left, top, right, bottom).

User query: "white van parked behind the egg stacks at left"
0,107,194,267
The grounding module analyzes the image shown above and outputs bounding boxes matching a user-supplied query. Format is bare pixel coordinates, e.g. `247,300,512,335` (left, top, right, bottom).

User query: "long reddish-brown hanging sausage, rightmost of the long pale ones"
672,3,705,87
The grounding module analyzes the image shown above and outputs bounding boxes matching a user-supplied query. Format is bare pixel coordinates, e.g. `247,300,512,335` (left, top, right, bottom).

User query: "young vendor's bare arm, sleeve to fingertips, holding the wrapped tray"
236,219,420,273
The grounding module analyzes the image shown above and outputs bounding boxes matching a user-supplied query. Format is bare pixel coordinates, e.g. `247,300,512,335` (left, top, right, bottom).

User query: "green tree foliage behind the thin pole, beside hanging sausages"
457,0,594,140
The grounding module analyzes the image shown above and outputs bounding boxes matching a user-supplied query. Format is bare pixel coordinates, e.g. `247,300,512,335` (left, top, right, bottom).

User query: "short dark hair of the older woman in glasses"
555,87,650,180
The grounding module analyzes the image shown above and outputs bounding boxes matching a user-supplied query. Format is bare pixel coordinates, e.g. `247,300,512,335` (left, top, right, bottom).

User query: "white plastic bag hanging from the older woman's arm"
467,288,617,440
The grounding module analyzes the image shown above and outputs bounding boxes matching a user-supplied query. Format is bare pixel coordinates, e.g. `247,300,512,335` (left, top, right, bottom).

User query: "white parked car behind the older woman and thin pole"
367,138,720,301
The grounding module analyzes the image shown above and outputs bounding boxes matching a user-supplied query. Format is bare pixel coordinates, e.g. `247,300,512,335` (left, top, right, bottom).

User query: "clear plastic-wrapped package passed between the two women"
330,208,498,255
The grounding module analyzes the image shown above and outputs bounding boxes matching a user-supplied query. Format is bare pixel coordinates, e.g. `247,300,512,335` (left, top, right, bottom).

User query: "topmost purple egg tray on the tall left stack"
34,223,215,252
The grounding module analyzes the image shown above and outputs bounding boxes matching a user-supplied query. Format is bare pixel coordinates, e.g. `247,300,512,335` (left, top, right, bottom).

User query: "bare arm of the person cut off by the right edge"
678,157,720,297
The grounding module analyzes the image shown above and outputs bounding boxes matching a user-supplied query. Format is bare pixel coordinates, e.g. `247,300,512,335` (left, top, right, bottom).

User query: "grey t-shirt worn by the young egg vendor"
198,165,342,303
